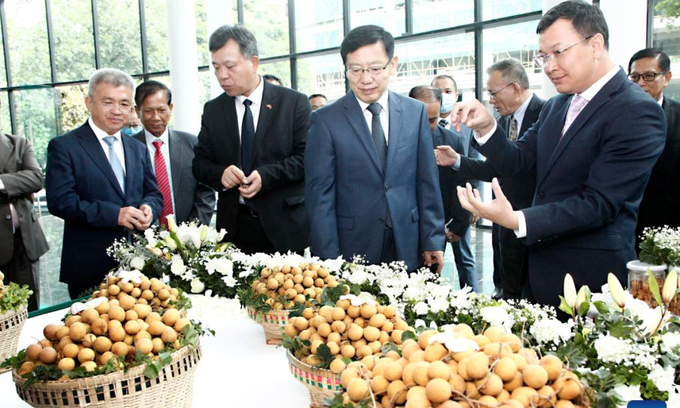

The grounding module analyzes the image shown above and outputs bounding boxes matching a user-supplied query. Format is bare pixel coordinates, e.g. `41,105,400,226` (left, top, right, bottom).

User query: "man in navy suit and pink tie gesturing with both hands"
438,1,666,306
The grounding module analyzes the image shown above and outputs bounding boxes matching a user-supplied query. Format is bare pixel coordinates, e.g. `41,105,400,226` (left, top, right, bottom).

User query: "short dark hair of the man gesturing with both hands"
536,0,609,49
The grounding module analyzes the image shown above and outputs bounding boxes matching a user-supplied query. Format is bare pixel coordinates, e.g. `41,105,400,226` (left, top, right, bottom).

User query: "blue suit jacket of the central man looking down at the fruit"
305,91,445,270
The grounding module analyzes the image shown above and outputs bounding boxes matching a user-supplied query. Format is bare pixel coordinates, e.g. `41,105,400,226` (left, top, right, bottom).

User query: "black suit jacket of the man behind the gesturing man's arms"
460,95,545,210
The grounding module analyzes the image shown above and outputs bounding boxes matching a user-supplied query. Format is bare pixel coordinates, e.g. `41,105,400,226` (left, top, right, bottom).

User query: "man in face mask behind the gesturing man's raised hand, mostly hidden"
431,75,480,292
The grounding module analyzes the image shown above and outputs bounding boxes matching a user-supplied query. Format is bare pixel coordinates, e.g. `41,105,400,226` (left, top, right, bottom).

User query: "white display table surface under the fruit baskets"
0,299,310,408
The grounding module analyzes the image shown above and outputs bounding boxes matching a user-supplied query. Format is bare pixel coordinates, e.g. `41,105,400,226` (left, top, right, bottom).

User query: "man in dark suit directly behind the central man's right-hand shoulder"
408,85,477,282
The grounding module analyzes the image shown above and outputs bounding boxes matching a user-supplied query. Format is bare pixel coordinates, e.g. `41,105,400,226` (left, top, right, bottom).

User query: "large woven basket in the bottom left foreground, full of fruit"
12,346,201,408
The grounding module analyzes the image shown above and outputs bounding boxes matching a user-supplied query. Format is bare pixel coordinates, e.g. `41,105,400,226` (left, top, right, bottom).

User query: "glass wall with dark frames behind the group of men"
0,0,660,306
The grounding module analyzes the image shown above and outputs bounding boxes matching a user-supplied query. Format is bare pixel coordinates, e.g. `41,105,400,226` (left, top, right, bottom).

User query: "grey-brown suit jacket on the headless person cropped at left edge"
0,134,49,265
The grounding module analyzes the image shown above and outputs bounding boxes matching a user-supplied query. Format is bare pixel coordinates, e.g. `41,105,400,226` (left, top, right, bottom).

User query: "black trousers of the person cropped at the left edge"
0,229,40,312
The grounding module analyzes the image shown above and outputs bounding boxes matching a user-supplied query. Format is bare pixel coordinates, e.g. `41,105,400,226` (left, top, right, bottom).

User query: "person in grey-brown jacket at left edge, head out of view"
0,134,49,311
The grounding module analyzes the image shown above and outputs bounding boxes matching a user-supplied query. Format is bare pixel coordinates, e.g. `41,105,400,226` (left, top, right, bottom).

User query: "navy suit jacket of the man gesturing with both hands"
473,70,666,305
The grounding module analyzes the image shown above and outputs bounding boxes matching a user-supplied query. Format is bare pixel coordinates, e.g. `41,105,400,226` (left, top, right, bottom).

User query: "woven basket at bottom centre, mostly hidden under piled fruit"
286,351,342,408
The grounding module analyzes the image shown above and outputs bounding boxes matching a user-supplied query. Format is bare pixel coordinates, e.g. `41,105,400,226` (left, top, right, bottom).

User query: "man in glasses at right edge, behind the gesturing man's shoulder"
628,48,680,253
